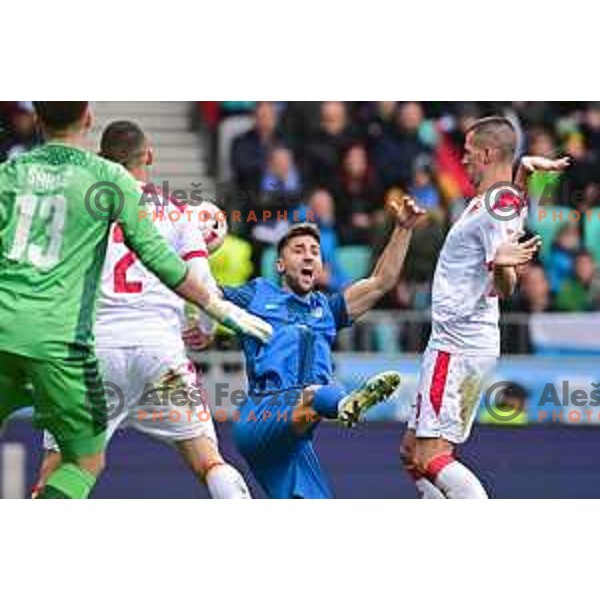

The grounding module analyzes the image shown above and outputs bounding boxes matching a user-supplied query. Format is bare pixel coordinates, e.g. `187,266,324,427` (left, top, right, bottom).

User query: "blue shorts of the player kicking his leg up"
233,396,333,498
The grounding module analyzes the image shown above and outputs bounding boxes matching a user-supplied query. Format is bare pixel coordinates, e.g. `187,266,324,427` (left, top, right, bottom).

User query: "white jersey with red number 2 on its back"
95,187,209,347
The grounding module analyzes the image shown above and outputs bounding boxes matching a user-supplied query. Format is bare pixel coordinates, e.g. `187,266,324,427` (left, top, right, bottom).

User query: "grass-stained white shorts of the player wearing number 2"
44,346,216,450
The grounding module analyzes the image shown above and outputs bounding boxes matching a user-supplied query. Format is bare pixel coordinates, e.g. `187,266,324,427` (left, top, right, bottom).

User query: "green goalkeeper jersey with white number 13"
0,143,187,359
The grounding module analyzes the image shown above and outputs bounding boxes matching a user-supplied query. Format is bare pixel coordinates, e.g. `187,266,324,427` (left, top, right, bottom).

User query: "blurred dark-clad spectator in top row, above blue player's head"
303,102,357,190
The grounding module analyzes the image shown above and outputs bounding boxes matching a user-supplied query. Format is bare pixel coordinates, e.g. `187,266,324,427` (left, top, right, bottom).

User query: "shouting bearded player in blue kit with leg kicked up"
218,197,424,498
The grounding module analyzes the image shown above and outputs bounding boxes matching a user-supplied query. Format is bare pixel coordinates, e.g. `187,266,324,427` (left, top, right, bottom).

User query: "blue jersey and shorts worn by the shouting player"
223,278,351,498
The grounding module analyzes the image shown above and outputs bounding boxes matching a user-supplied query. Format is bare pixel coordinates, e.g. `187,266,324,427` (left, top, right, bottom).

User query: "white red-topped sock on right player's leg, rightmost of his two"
426,454,488,500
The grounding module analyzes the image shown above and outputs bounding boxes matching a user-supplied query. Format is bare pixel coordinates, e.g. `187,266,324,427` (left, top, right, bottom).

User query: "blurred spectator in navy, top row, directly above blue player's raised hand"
373,102,430,190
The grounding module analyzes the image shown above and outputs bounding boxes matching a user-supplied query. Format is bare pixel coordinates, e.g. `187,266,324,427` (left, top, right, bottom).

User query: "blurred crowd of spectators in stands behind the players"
199,101,600,326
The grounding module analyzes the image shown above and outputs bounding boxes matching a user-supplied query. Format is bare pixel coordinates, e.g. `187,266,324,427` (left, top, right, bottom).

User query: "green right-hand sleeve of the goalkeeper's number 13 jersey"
111,165,188,288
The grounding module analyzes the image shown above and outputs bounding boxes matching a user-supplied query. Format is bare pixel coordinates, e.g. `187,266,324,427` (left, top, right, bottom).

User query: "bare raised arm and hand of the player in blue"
344,196,425,320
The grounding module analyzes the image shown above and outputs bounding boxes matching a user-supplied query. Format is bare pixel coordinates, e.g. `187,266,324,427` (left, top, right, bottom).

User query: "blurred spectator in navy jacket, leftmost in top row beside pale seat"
231,102,281,192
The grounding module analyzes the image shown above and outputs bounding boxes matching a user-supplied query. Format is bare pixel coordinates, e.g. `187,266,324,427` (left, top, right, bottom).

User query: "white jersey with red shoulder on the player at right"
429,194,526,356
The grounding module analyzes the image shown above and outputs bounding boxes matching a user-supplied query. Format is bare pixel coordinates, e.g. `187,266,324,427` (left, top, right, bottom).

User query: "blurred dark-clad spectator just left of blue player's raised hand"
335,144,383,244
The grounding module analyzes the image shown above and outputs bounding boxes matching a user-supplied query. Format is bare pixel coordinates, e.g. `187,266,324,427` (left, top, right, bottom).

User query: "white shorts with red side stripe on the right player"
408,348,497,444
